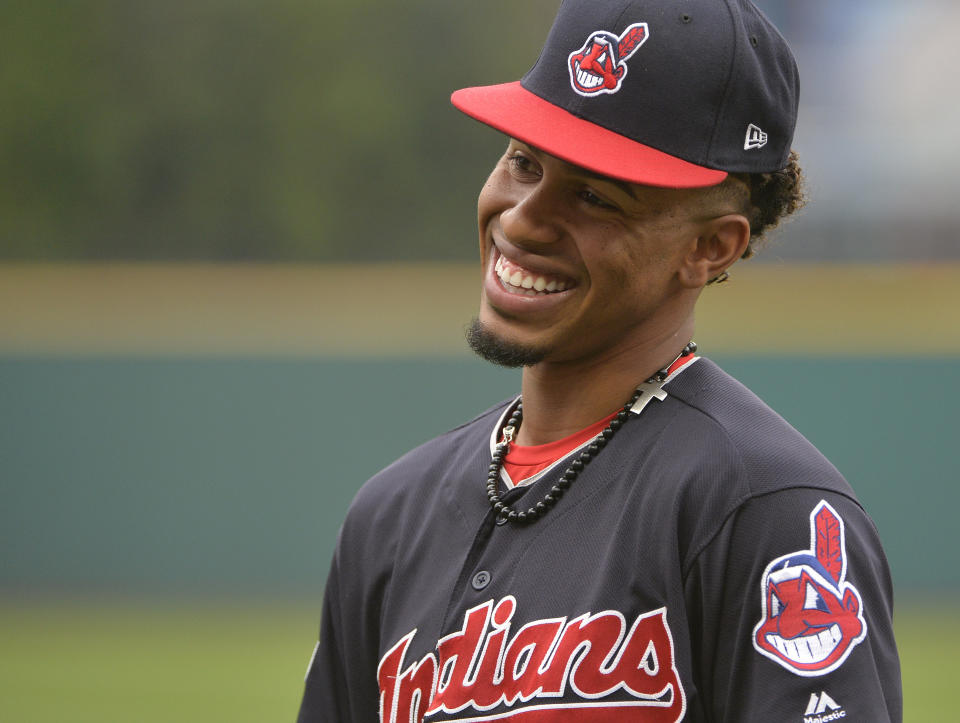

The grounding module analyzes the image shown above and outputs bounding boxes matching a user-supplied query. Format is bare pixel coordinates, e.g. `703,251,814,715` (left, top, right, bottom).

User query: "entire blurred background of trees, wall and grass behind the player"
0,0,960,723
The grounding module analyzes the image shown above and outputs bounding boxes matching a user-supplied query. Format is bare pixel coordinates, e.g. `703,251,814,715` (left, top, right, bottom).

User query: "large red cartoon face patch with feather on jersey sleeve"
753,500,867,676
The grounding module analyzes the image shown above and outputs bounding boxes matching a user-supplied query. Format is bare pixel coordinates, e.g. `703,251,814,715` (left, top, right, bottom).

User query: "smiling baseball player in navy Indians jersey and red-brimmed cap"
300,0,902,723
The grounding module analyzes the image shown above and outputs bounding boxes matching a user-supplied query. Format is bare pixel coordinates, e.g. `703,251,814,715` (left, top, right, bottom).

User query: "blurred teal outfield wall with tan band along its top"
0,264,960,599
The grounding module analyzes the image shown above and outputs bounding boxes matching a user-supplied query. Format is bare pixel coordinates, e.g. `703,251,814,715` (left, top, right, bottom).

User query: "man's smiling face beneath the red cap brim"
475,140,703,364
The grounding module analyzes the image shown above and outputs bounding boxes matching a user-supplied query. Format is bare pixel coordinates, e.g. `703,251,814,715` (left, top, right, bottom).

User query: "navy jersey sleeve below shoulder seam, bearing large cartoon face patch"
686,487,900,721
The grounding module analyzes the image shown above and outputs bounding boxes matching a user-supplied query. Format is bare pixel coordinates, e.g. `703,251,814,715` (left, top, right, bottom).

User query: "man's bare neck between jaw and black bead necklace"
517,319,693,445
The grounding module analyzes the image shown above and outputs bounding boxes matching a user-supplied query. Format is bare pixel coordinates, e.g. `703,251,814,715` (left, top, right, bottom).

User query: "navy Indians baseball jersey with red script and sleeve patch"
299,358,902,723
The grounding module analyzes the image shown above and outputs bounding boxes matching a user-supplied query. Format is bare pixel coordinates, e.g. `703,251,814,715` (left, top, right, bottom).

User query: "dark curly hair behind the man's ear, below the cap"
736,151,807,259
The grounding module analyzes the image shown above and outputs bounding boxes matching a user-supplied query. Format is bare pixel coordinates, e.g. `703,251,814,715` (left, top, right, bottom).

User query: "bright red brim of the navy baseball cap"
450,81,727,188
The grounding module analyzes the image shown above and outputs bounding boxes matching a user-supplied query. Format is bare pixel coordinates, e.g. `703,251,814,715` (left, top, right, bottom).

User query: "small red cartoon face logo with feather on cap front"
567,23,649,96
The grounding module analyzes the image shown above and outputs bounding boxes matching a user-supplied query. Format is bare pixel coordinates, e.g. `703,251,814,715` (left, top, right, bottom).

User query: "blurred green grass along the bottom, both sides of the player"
0,603,960,723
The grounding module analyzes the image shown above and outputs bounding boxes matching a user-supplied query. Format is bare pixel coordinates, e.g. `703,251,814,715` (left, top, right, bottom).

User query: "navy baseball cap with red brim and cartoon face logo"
451,0,799,188
